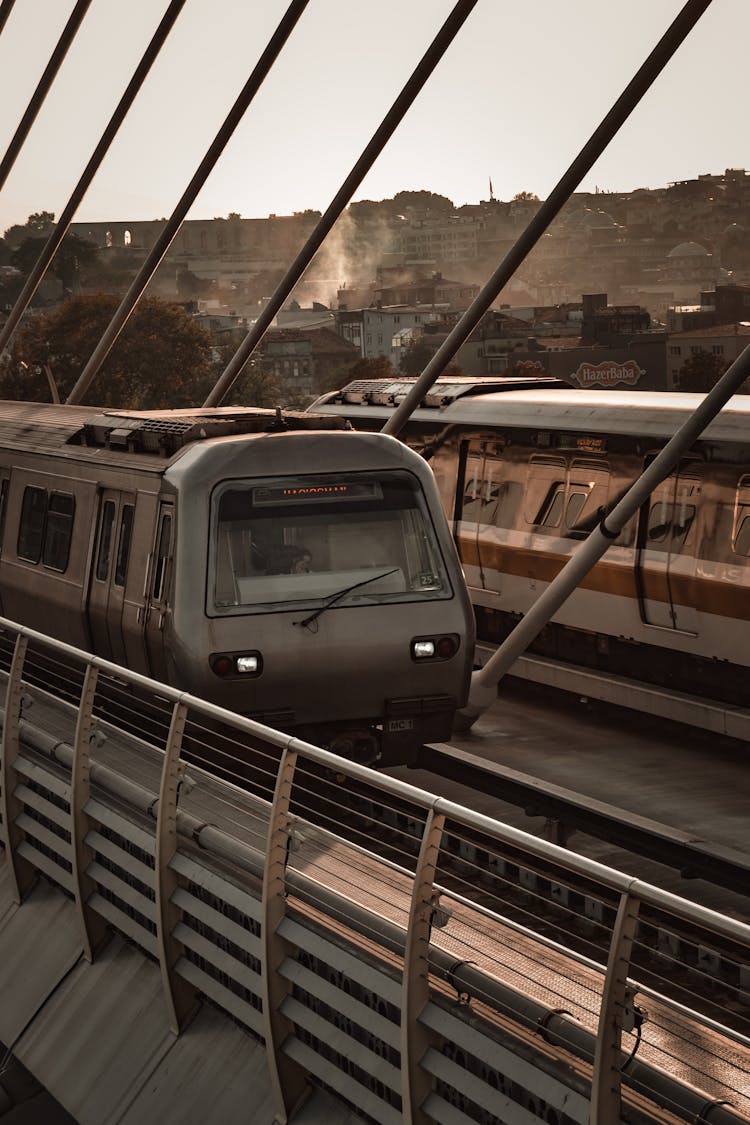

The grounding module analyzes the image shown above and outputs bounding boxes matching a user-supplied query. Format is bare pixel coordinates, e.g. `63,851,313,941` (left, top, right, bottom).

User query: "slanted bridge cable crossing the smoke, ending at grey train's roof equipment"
204,0,477,406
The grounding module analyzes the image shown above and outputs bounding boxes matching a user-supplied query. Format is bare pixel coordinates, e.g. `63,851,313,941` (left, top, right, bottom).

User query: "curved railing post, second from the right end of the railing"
401,809,445,1125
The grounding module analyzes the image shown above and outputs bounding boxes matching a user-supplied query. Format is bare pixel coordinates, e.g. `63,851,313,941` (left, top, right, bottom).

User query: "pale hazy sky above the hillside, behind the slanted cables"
0,0,750,233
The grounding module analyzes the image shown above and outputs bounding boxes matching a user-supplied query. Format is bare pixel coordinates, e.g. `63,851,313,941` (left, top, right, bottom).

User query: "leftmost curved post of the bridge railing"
0,633,36,903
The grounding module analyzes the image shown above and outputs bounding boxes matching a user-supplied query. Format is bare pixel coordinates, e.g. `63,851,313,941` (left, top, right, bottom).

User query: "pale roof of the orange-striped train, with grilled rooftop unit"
313,379,750,443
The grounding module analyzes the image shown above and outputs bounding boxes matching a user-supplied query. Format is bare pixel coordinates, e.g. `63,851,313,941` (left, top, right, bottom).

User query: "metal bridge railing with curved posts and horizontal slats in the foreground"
0,620,750,1125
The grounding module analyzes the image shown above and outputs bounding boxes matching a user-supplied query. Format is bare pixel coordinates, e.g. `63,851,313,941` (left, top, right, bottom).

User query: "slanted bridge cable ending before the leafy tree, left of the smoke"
66,0,309,404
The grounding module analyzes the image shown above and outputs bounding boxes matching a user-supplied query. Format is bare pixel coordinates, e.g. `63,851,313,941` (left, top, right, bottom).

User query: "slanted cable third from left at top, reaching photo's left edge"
0,0,186,355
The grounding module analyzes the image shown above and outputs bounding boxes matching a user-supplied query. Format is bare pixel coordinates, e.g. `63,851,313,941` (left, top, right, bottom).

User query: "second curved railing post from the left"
71,664,109,961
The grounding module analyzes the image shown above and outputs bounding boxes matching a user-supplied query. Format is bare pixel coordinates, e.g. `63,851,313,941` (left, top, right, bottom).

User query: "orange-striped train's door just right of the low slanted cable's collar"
635,461,701,633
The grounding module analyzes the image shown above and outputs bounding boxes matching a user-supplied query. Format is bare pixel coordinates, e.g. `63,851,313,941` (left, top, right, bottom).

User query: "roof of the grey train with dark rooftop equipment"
0,401,346,467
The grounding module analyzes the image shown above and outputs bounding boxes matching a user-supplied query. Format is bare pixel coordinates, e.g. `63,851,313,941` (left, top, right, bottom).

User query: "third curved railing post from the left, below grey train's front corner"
155,700,198,1035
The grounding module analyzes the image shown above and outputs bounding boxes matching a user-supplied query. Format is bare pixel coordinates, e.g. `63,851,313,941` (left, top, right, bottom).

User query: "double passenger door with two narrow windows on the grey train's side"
88,489,135,671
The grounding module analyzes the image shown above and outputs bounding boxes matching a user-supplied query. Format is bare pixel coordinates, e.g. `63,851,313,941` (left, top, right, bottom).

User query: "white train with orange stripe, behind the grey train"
313,379,750,704
